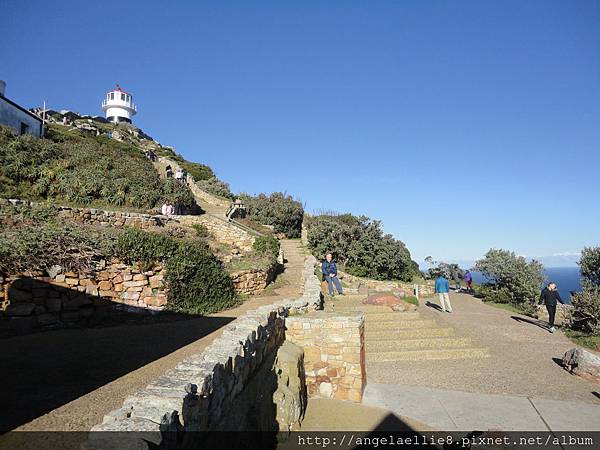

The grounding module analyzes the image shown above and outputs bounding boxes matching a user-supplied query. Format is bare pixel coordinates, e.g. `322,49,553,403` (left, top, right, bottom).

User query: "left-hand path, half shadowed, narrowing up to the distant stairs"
0,240,305,432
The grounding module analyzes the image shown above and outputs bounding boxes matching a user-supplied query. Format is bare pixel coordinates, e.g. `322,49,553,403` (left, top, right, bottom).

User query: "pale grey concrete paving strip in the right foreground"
363,381,600,431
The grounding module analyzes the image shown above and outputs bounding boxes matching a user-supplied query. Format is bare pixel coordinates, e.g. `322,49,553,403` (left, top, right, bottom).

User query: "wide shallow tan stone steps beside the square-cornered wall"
325,294,490,363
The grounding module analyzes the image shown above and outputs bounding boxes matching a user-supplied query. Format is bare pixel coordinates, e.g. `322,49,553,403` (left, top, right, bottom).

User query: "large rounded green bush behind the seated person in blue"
308,214,419,281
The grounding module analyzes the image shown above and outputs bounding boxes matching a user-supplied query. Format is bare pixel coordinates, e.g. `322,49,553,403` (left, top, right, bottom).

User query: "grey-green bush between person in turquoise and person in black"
475,249,544,308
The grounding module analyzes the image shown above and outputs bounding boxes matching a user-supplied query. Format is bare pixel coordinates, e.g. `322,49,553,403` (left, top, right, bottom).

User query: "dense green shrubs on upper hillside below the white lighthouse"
0,125,194,209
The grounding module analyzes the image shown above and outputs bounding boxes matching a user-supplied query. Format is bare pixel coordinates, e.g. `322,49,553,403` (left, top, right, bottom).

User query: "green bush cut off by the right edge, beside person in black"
571,247,600,334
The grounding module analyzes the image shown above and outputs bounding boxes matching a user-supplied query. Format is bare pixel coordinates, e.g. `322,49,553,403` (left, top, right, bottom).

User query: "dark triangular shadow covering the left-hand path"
0,316,233,433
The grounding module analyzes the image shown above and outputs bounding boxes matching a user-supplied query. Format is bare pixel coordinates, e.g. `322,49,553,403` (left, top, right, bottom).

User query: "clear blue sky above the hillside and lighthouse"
0,0,600,261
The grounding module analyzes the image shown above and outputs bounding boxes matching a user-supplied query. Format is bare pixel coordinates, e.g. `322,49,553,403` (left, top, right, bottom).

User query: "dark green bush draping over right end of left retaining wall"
116,228,238,314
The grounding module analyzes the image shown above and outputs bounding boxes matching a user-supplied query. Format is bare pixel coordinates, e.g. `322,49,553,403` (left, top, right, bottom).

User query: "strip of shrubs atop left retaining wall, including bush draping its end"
0,206,239,314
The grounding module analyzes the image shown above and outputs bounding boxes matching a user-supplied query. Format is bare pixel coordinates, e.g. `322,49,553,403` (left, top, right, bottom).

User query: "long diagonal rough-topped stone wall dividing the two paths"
84,257,322,450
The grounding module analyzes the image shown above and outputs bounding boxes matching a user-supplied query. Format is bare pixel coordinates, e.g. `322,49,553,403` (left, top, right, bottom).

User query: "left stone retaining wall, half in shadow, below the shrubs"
0,260,167,332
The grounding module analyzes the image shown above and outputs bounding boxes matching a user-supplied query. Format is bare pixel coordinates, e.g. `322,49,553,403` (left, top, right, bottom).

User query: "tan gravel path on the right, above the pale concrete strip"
368,294,600,404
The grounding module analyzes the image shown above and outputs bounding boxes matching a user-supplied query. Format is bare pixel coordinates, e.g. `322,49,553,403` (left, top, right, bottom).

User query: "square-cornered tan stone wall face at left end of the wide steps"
286,312,367,402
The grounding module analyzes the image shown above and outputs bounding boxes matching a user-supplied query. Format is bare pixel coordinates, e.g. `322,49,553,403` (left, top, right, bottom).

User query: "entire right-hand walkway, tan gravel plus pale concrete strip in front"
363,294,600,431
